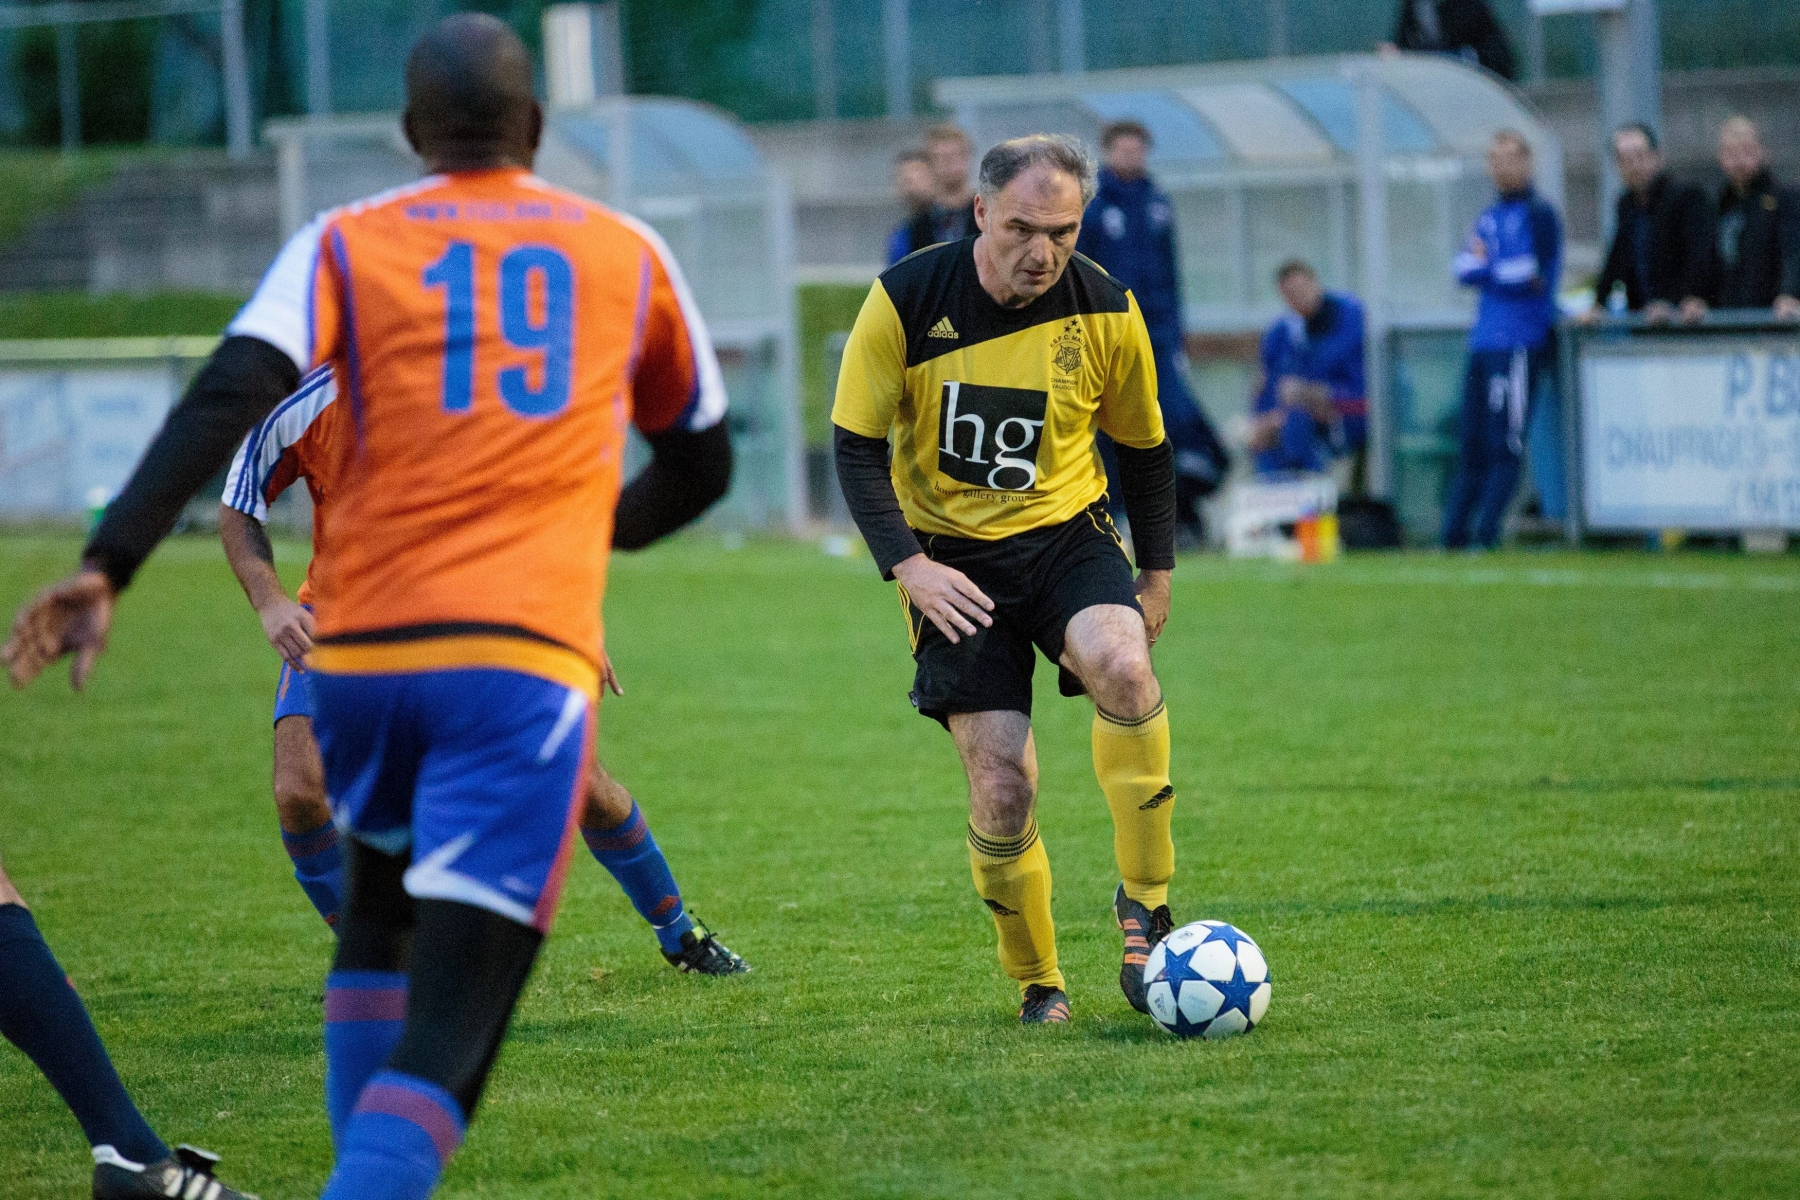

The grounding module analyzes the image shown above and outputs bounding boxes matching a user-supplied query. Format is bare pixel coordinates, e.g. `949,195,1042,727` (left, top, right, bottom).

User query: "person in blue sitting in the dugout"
1249,259,1368,473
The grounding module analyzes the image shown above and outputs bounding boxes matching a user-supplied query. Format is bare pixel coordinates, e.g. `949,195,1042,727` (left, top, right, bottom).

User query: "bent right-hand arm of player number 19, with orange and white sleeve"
612,230,731,551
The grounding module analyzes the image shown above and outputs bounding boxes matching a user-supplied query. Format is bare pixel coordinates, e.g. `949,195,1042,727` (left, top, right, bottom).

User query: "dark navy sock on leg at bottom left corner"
0,905,169,1162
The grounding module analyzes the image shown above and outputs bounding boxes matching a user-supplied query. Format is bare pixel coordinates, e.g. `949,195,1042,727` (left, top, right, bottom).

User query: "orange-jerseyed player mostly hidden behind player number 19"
220,367,751,975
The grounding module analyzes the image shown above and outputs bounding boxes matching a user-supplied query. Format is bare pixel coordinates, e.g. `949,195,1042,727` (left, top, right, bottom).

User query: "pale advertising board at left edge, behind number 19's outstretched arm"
0,362,180,516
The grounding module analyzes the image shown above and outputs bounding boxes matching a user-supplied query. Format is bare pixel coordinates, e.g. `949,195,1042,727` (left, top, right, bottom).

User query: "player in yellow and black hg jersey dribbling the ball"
832,135,1175,1024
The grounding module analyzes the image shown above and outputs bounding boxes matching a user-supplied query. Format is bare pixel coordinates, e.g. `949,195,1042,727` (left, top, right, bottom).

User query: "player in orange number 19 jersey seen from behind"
4,14,729,1200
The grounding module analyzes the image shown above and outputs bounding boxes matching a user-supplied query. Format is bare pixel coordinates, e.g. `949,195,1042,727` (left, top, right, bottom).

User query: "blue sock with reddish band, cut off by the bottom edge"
320,1070,468,1200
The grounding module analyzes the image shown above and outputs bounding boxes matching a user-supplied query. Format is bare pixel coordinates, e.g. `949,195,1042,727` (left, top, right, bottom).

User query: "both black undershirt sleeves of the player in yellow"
832,426,1175,579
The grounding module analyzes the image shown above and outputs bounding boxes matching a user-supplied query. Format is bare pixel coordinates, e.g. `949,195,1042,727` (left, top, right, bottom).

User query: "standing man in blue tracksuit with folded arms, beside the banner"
1444,130,1562,549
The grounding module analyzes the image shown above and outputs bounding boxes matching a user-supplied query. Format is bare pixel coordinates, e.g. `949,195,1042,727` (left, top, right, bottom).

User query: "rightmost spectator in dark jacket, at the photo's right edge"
1712,117,1800,320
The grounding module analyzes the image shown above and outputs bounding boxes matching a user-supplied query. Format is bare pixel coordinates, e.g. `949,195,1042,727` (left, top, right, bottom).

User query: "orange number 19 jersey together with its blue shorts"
225,169,725,930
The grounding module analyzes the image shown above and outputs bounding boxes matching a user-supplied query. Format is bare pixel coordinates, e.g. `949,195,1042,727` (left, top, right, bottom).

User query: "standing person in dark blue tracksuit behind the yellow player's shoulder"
1075,121,1231,549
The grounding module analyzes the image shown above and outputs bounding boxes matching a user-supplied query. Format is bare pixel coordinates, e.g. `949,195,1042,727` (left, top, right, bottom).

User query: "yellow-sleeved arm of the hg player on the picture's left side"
832,281,994,644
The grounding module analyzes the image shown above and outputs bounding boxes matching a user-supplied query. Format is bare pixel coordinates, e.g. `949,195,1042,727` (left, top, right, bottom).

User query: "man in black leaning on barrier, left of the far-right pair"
1582,124,1712,324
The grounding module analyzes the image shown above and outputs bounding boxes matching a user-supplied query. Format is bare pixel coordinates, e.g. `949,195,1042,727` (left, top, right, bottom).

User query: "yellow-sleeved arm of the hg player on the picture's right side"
1100,299,1175,642
